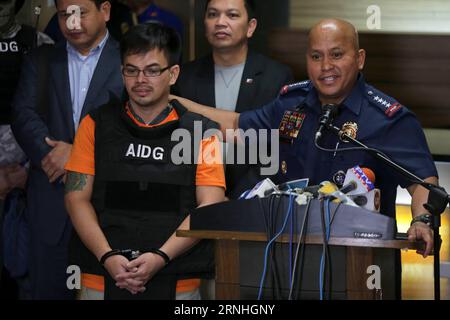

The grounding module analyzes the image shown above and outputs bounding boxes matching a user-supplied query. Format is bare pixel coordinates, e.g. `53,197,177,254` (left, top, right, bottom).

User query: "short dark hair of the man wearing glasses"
120,22,181,66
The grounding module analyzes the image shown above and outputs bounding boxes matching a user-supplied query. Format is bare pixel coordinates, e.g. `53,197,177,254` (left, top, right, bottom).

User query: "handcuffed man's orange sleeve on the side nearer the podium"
195,136,226,189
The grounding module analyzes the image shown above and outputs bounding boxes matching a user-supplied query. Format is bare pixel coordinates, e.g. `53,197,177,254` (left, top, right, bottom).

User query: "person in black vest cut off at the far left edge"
0,0,52,286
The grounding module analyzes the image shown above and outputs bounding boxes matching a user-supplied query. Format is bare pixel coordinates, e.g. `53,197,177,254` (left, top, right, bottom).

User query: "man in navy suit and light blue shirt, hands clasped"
12,0,123,299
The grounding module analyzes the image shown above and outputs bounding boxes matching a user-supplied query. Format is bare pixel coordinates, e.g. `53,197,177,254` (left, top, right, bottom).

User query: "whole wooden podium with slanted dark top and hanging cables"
177,195,415,300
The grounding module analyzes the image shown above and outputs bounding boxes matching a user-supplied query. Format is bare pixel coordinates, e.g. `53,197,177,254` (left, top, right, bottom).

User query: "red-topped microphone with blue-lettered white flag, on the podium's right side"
340,166,375,195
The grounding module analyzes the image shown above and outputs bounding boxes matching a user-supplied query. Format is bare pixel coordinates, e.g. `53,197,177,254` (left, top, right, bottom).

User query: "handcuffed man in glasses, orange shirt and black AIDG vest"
65,24,225,299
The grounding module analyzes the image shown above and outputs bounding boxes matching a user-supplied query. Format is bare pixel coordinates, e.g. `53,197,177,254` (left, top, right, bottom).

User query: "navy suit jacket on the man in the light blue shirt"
12,37,123,245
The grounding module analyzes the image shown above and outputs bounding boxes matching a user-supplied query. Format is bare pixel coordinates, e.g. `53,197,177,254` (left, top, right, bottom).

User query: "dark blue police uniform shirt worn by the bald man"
239,74,437,217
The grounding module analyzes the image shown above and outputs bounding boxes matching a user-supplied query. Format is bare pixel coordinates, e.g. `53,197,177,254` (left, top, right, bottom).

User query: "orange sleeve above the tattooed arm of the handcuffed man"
65,115,95,176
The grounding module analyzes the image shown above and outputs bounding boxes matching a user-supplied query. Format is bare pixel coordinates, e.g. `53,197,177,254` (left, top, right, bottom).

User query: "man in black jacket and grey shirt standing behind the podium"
173,0,293,198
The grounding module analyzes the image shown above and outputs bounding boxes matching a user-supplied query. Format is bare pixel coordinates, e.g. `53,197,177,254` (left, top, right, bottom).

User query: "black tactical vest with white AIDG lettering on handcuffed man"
72,101,221,299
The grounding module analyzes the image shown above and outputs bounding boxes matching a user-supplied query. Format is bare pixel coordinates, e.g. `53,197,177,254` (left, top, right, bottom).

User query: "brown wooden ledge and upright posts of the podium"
177,230,416,300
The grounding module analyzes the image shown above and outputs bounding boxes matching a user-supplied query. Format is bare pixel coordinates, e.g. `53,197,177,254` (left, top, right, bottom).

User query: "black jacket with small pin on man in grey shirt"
172,51,293,198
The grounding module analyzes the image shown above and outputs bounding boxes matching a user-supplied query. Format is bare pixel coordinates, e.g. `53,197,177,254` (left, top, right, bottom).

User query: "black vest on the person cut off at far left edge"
0,25,36,125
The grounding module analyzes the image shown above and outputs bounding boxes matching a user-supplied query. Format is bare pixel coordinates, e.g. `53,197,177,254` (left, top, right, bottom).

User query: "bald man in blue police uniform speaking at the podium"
171,19,438,298
